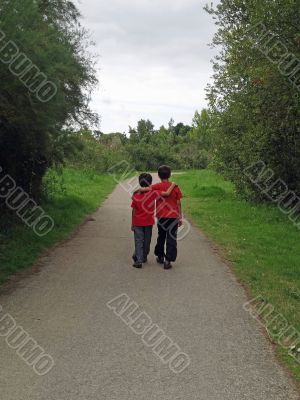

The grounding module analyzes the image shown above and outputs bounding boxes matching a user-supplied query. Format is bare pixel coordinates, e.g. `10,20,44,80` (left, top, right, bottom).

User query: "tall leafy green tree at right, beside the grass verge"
207,0,300,198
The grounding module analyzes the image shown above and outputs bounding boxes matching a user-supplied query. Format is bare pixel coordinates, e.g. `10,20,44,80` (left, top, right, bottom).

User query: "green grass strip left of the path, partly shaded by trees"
0,169,115,284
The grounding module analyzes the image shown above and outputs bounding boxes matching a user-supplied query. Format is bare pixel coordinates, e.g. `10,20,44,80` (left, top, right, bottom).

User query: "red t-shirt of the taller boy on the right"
152,182,182,218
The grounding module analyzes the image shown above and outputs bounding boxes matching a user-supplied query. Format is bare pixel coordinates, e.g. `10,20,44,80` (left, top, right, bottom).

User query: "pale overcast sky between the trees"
79,0,216,133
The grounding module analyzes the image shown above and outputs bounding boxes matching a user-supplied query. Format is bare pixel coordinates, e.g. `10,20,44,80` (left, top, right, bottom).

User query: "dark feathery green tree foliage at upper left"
0,0,97,197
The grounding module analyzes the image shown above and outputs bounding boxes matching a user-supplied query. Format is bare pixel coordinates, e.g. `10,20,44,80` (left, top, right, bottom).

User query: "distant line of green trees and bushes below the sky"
68,110,212,172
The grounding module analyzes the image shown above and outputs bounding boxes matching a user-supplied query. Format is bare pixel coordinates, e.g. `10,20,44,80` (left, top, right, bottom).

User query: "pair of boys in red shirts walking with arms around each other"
131,165,182,269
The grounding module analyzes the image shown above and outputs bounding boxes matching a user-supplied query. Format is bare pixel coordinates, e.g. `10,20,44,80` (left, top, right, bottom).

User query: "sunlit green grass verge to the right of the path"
175,171,300,382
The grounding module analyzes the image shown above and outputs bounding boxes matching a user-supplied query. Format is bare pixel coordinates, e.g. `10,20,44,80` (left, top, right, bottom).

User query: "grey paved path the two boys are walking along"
0,179,298,400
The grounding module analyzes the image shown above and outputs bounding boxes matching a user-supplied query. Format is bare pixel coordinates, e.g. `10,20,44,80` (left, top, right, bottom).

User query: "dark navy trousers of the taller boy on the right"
155,218,178,262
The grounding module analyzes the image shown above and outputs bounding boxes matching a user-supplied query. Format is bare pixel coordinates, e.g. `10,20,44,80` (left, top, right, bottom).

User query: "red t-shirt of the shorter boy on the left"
131,190,161,226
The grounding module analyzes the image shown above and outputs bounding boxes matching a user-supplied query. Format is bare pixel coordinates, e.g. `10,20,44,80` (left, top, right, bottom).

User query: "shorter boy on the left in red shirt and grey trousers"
131,174,175,268
